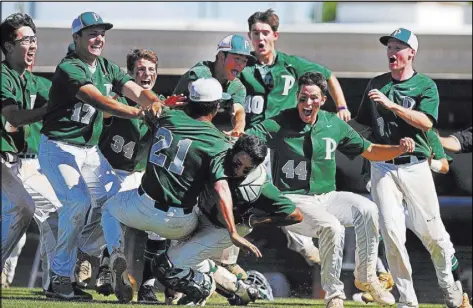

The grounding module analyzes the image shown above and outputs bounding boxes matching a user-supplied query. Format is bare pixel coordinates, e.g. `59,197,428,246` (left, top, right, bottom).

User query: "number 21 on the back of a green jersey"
149,127,192,175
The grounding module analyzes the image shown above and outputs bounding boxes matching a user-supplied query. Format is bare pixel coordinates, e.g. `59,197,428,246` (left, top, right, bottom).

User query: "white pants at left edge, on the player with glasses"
1,158,35,270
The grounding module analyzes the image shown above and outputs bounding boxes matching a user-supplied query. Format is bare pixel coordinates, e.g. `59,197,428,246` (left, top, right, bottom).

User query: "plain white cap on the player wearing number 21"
189,78,231,102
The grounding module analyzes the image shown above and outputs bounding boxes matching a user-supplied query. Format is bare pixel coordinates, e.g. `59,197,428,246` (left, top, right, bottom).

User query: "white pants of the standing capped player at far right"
371,160,454,305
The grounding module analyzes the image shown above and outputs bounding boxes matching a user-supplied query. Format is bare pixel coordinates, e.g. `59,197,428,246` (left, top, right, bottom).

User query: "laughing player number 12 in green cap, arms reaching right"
39,12,159,299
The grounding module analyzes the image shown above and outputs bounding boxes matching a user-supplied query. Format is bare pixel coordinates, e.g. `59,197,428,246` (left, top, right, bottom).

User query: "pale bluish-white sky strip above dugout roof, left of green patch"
1,2,318,25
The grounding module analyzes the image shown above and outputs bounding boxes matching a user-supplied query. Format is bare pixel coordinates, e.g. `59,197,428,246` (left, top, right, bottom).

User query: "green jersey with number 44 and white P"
247,108,371,194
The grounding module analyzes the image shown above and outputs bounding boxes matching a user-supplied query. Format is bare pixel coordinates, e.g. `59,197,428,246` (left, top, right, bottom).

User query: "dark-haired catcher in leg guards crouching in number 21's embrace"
157,136,303,305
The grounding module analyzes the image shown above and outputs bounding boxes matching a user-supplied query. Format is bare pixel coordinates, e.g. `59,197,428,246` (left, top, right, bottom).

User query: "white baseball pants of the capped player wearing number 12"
39,135,121,277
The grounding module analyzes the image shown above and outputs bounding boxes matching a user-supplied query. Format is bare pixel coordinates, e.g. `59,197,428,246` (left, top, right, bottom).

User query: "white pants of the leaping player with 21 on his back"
102,185,198,253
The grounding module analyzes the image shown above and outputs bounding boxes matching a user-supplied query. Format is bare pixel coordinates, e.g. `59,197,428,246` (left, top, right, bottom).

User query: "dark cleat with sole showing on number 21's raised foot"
110,251,133,303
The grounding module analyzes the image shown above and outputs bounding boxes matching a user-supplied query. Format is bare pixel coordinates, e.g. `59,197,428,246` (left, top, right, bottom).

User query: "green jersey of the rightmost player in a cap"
356,73,439,157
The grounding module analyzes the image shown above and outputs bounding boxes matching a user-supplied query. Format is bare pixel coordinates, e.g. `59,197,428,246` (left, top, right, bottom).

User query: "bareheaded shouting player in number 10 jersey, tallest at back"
235,9,351,270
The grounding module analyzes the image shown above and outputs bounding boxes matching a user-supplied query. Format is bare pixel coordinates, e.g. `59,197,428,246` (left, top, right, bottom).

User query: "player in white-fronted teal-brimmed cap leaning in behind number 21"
174,34,255,136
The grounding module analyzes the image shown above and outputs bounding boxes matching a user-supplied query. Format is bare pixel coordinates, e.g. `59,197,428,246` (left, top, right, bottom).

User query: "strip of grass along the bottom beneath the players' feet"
1,288,443,308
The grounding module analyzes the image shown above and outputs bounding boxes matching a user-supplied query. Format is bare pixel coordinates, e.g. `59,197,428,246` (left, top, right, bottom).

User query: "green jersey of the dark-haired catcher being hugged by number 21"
199,164,296,228
